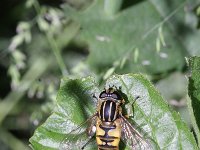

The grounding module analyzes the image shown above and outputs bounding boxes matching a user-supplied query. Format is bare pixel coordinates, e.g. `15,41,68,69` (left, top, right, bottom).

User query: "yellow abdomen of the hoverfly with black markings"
96,119,121,150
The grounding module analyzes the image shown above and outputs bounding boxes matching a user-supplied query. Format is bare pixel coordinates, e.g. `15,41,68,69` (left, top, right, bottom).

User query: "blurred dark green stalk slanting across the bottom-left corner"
0,128,30,150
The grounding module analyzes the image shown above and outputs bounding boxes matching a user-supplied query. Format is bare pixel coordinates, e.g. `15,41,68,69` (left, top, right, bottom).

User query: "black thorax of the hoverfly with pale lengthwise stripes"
99,100,118,122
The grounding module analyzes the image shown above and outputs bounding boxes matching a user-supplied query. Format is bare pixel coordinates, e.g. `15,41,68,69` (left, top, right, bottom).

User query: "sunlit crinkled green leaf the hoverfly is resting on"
30,74,198,150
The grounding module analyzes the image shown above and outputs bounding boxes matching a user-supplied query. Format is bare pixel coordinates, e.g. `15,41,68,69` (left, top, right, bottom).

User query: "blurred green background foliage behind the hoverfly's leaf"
0,0,200,150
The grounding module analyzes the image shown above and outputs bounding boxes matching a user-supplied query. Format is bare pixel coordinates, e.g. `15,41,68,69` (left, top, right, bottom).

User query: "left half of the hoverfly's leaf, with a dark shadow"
30,77,98,150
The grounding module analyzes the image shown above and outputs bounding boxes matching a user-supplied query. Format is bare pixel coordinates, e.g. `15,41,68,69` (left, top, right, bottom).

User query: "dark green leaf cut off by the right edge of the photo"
188,57,200,144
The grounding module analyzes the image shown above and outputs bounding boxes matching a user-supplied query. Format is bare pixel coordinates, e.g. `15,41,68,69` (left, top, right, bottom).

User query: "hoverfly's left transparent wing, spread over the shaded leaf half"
59,114,97,150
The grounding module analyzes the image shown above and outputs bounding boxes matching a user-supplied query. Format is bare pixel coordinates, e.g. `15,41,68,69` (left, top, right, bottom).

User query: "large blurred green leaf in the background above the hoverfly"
63,0,186,74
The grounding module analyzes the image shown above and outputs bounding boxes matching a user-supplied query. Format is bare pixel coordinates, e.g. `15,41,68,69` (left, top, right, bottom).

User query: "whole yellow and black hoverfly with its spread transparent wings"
60,87,152,150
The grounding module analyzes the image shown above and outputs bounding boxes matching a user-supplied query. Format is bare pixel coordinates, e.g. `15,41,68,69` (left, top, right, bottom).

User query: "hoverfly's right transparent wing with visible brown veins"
120,115,153,150
